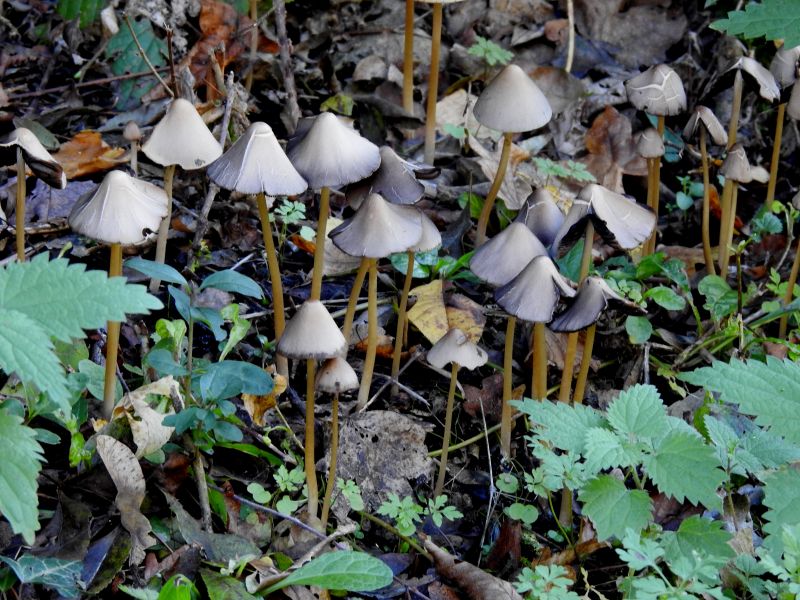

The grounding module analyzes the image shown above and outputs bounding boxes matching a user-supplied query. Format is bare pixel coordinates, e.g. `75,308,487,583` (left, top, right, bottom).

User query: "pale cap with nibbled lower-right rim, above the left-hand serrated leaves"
69,171,167,245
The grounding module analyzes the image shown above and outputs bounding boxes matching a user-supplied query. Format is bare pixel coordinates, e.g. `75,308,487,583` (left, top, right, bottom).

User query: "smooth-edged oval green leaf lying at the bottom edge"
265,551,392,595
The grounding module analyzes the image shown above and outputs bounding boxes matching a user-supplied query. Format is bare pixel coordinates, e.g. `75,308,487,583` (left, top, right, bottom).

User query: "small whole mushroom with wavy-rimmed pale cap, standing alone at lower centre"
428,329,489,498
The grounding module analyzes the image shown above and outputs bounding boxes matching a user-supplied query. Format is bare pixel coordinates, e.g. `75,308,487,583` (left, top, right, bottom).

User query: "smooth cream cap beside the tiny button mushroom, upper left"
142,98,222,171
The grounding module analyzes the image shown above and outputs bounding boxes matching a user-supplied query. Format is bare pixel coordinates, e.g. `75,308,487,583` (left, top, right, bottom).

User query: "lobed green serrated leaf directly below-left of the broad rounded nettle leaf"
579,475,653,540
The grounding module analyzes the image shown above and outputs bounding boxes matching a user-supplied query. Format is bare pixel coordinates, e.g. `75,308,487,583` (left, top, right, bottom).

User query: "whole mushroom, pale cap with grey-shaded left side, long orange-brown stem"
208,122,308,377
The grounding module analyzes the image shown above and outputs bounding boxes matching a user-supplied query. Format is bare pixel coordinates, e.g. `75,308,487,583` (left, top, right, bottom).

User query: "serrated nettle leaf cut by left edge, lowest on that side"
0,410,44,544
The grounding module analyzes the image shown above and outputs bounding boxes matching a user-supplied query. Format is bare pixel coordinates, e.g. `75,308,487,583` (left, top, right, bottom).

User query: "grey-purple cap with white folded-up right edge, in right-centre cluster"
494,256,575,323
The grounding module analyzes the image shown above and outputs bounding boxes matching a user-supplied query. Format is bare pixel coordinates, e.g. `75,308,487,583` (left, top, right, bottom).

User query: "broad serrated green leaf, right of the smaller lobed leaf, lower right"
644,430,725,508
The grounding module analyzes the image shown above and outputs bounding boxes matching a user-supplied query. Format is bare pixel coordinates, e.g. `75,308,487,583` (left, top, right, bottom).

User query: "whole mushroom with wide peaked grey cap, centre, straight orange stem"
330,194,422,410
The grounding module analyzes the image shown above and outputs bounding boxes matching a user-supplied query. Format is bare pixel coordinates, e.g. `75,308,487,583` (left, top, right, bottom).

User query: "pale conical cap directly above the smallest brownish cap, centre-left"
277,300,345,360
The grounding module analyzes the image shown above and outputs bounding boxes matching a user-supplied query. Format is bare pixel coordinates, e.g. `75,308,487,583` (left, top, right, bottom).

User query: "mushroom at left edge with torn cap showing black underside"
0,127,67,261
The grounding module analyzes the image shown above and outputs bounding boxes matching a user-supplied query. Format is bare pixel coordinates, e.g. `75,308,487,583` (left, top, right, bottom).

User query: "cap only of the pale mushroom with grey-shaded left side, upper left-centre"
208,122,308,196
